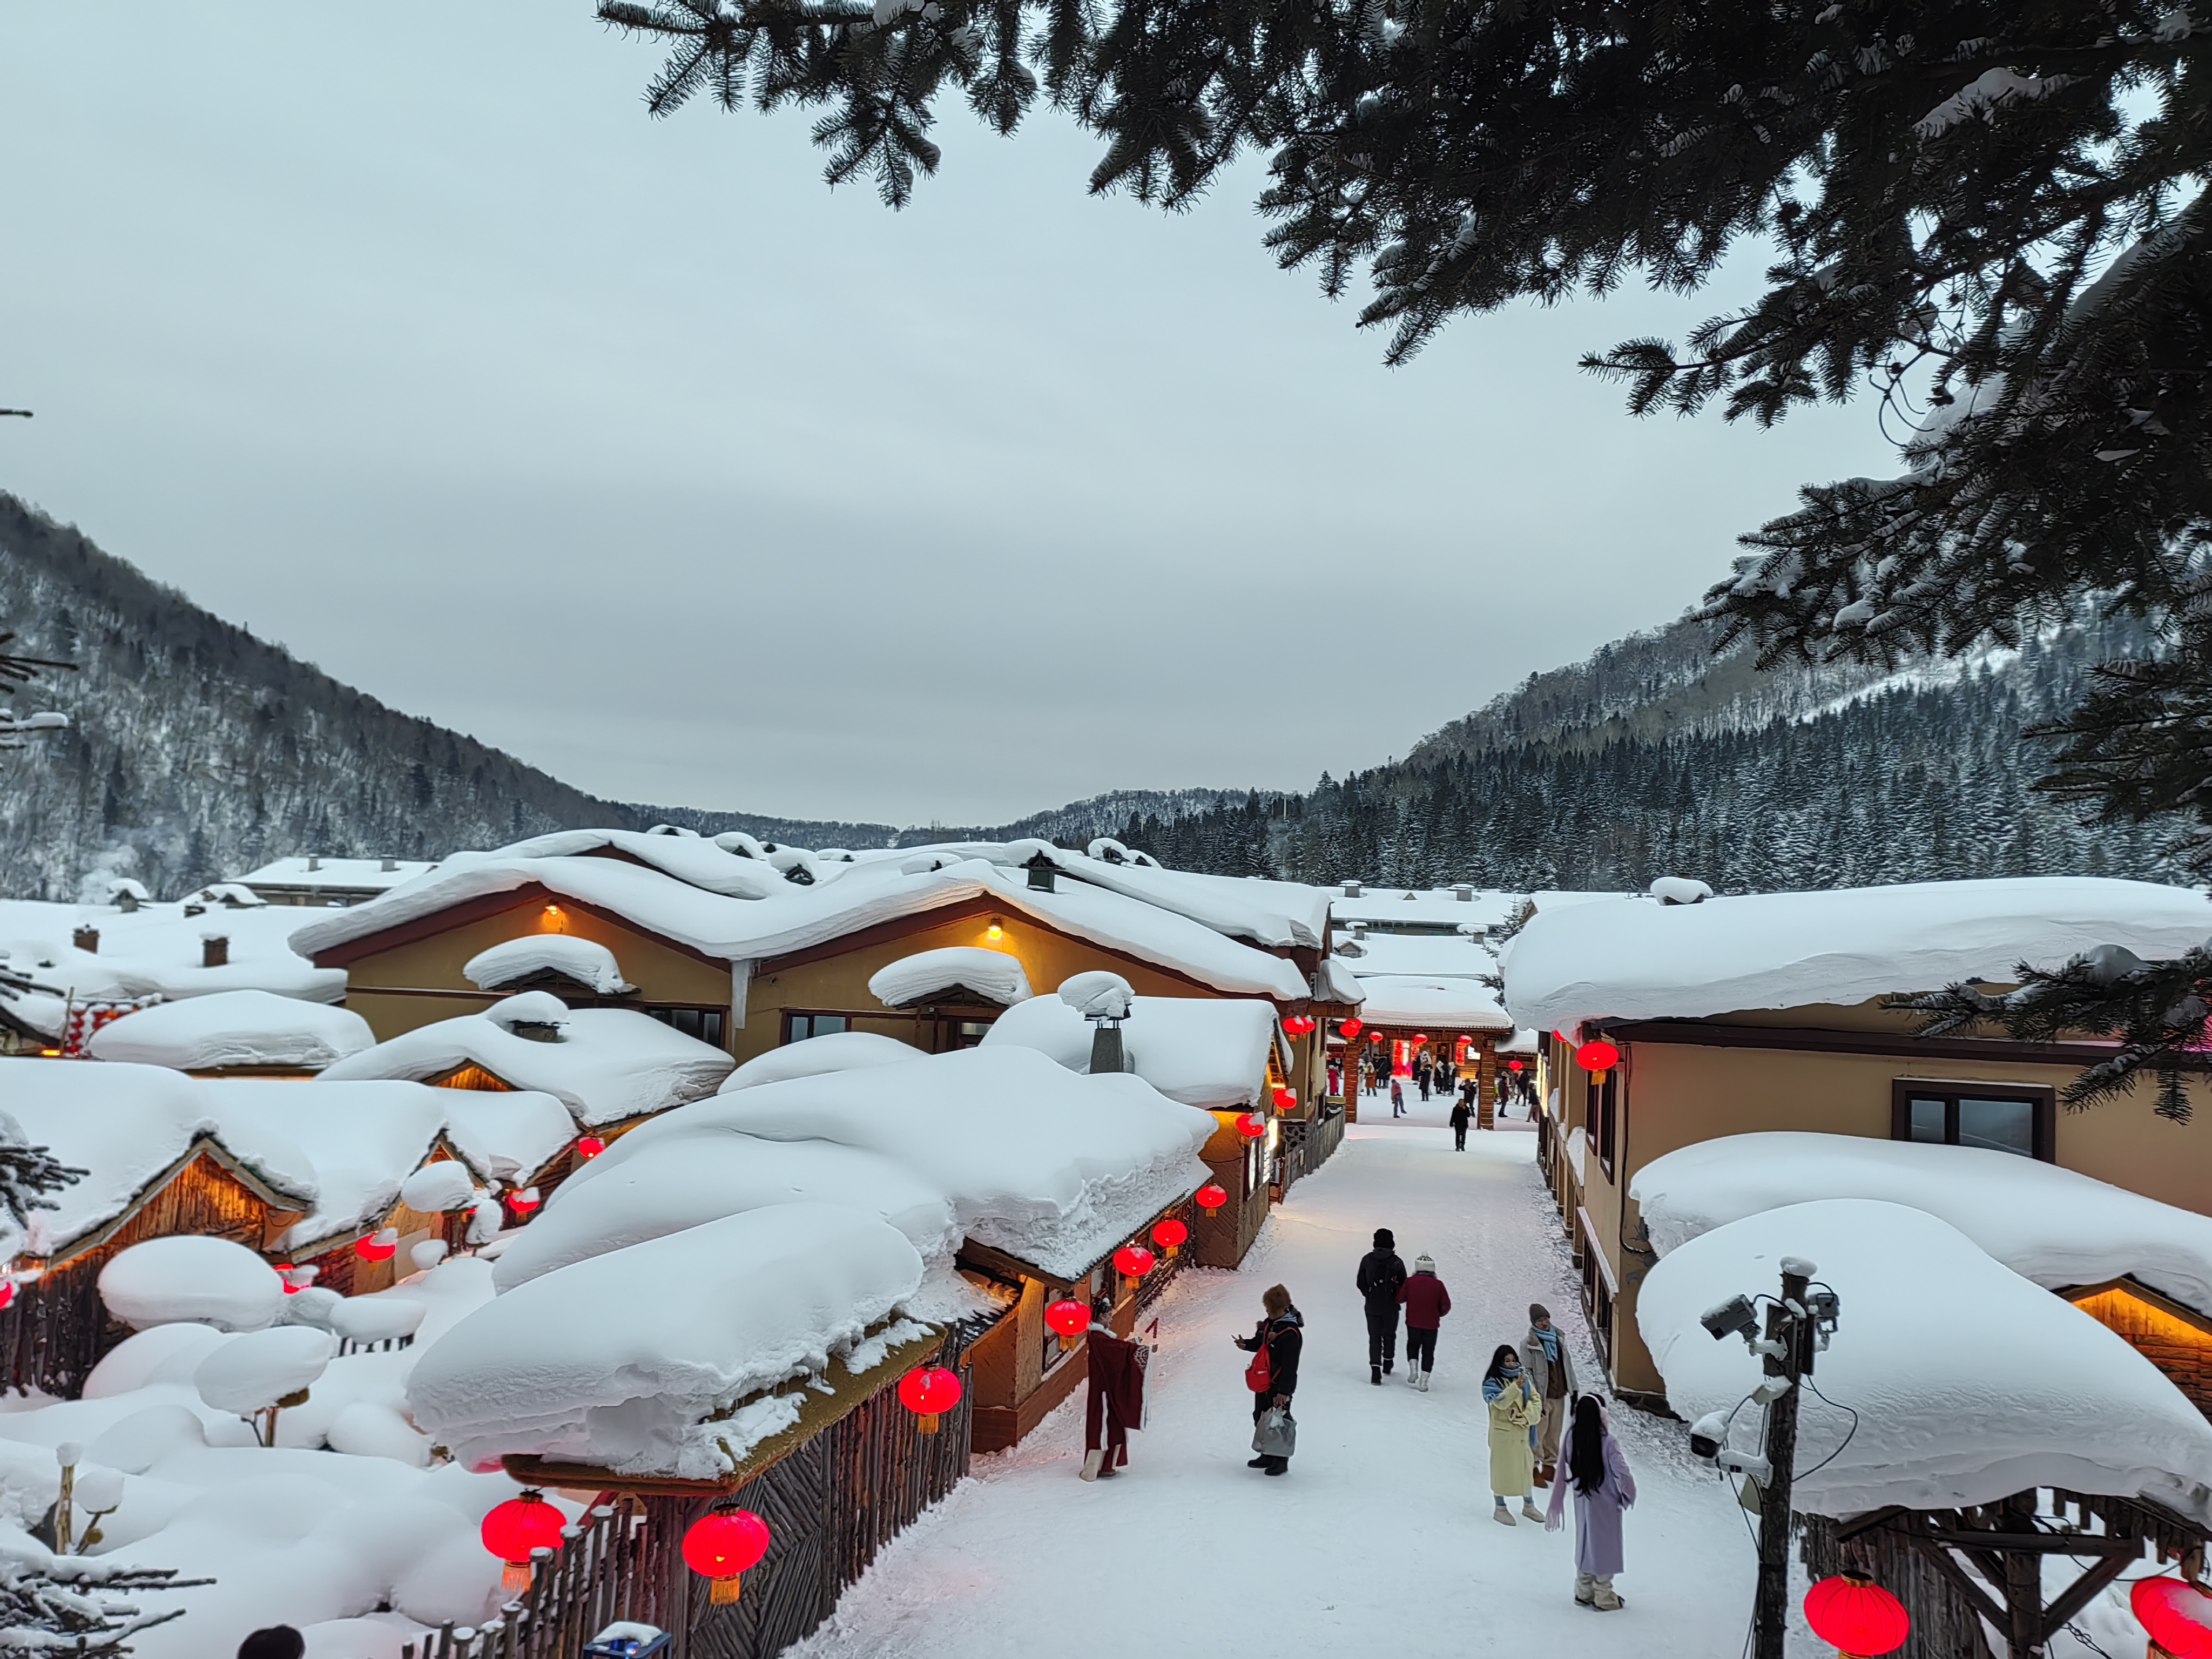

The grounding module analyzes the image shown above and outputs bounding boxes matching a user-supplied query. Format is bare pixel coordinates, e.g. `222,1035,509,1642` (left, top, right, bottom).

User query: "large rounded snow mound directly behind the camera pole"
1637,1199,2212,1520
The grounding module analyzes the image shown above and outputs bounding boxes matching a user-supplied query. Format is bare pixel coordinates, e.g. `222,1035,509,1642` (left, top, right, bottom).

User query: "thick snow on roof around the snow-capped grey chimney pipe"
982,997,1274,1110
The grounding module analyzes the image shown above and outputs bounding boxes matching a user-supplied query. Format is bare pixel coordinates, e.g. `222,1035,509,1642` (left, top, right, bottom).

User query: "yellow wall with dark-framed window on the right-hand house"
1568,1040,2212,1393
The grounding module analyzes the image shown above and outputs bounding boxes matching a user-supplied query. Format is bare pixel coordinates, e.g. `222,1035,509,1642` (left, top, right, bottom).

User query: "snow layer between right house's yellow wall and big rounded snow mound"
1628,1130,2212,1314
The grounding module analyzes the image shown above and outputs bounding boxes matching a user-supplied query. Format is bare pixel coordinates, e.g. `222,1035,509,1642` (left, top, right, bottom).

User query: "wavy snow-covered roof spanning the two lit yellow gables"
292,830,1320,1000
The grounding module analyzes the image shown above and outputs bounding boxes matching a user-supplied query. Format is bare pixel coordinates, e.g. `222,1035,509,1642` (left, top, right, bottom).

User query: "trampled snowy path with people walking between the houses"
792,1123,1752,1659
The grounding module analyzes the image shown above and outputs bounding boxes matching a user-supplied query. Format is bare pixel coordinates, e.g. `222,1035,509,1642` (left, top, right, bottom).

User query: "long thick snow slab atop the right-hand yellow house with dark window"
1504,876,2212,1031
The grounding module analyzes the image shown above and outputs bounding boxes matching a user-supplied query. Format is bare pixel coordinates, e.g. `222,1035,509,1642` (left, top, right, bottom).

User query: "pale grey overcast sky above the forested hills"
0,0,1889,823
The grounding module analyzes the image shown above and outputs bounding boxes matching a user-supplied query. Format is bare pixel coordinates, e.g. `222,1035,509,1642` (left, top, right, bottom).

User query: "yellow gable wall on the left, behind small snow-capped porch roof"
345,900,730,1042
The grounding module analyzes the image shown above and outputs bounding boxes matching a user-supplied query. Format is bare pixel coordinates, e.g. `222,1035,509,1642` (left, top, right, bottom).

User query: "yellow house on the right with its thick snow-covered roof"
1502,876,2212,1393
